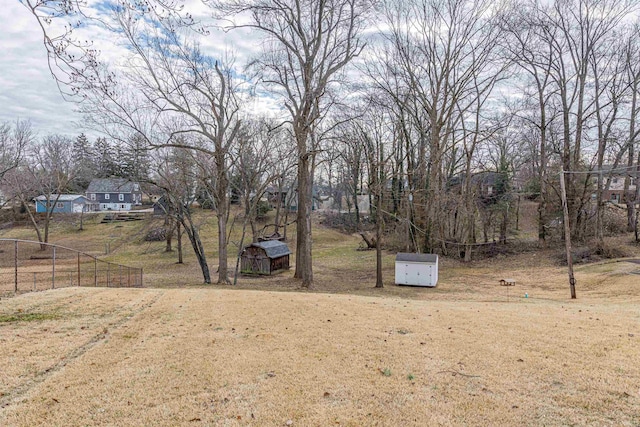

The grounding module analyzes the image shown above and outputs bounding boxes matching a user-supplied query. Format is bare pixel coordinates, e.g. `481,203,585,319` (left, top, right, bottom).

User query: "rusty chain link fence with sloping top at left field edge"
0,239,143,294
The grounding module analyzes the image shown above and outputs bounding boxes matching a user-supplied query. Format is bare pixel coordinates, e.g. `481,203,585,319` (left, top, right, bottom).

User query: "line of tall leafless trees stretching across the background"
11,0,640,286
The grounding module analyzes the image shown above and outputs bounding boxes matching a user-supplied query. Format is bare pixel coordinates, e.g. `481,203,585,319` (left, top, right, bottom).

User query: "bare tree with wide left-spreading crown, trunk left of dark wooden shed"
72,8,240,283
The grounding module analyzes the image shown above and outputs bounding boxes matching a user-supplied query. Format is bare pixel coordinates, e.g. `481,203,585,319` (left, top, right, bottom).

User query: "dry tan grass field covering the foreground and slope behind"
0,206,640,426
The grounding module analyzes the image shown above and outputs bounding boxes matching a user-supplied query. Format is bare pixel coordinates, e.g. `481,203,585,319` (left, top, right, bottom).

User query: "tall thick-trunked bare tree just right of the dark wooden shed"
214,0,364,287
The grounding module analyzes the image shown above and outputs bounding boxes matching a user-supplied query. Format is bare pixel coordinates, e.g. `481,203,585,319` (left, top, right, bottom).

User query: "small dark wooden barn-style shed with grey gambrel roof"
240,240,291,275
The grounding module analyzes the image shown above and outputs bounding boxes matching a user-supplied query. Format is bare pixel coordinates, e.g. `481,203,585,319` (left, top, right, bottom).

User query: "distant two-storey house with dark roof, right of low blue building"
86,178,142,211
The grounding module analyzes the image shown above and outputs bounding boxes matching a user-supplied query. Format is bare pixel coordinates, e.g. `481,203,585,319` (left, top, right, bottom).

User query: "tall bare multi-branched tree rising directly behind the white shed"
385,0,506,254
